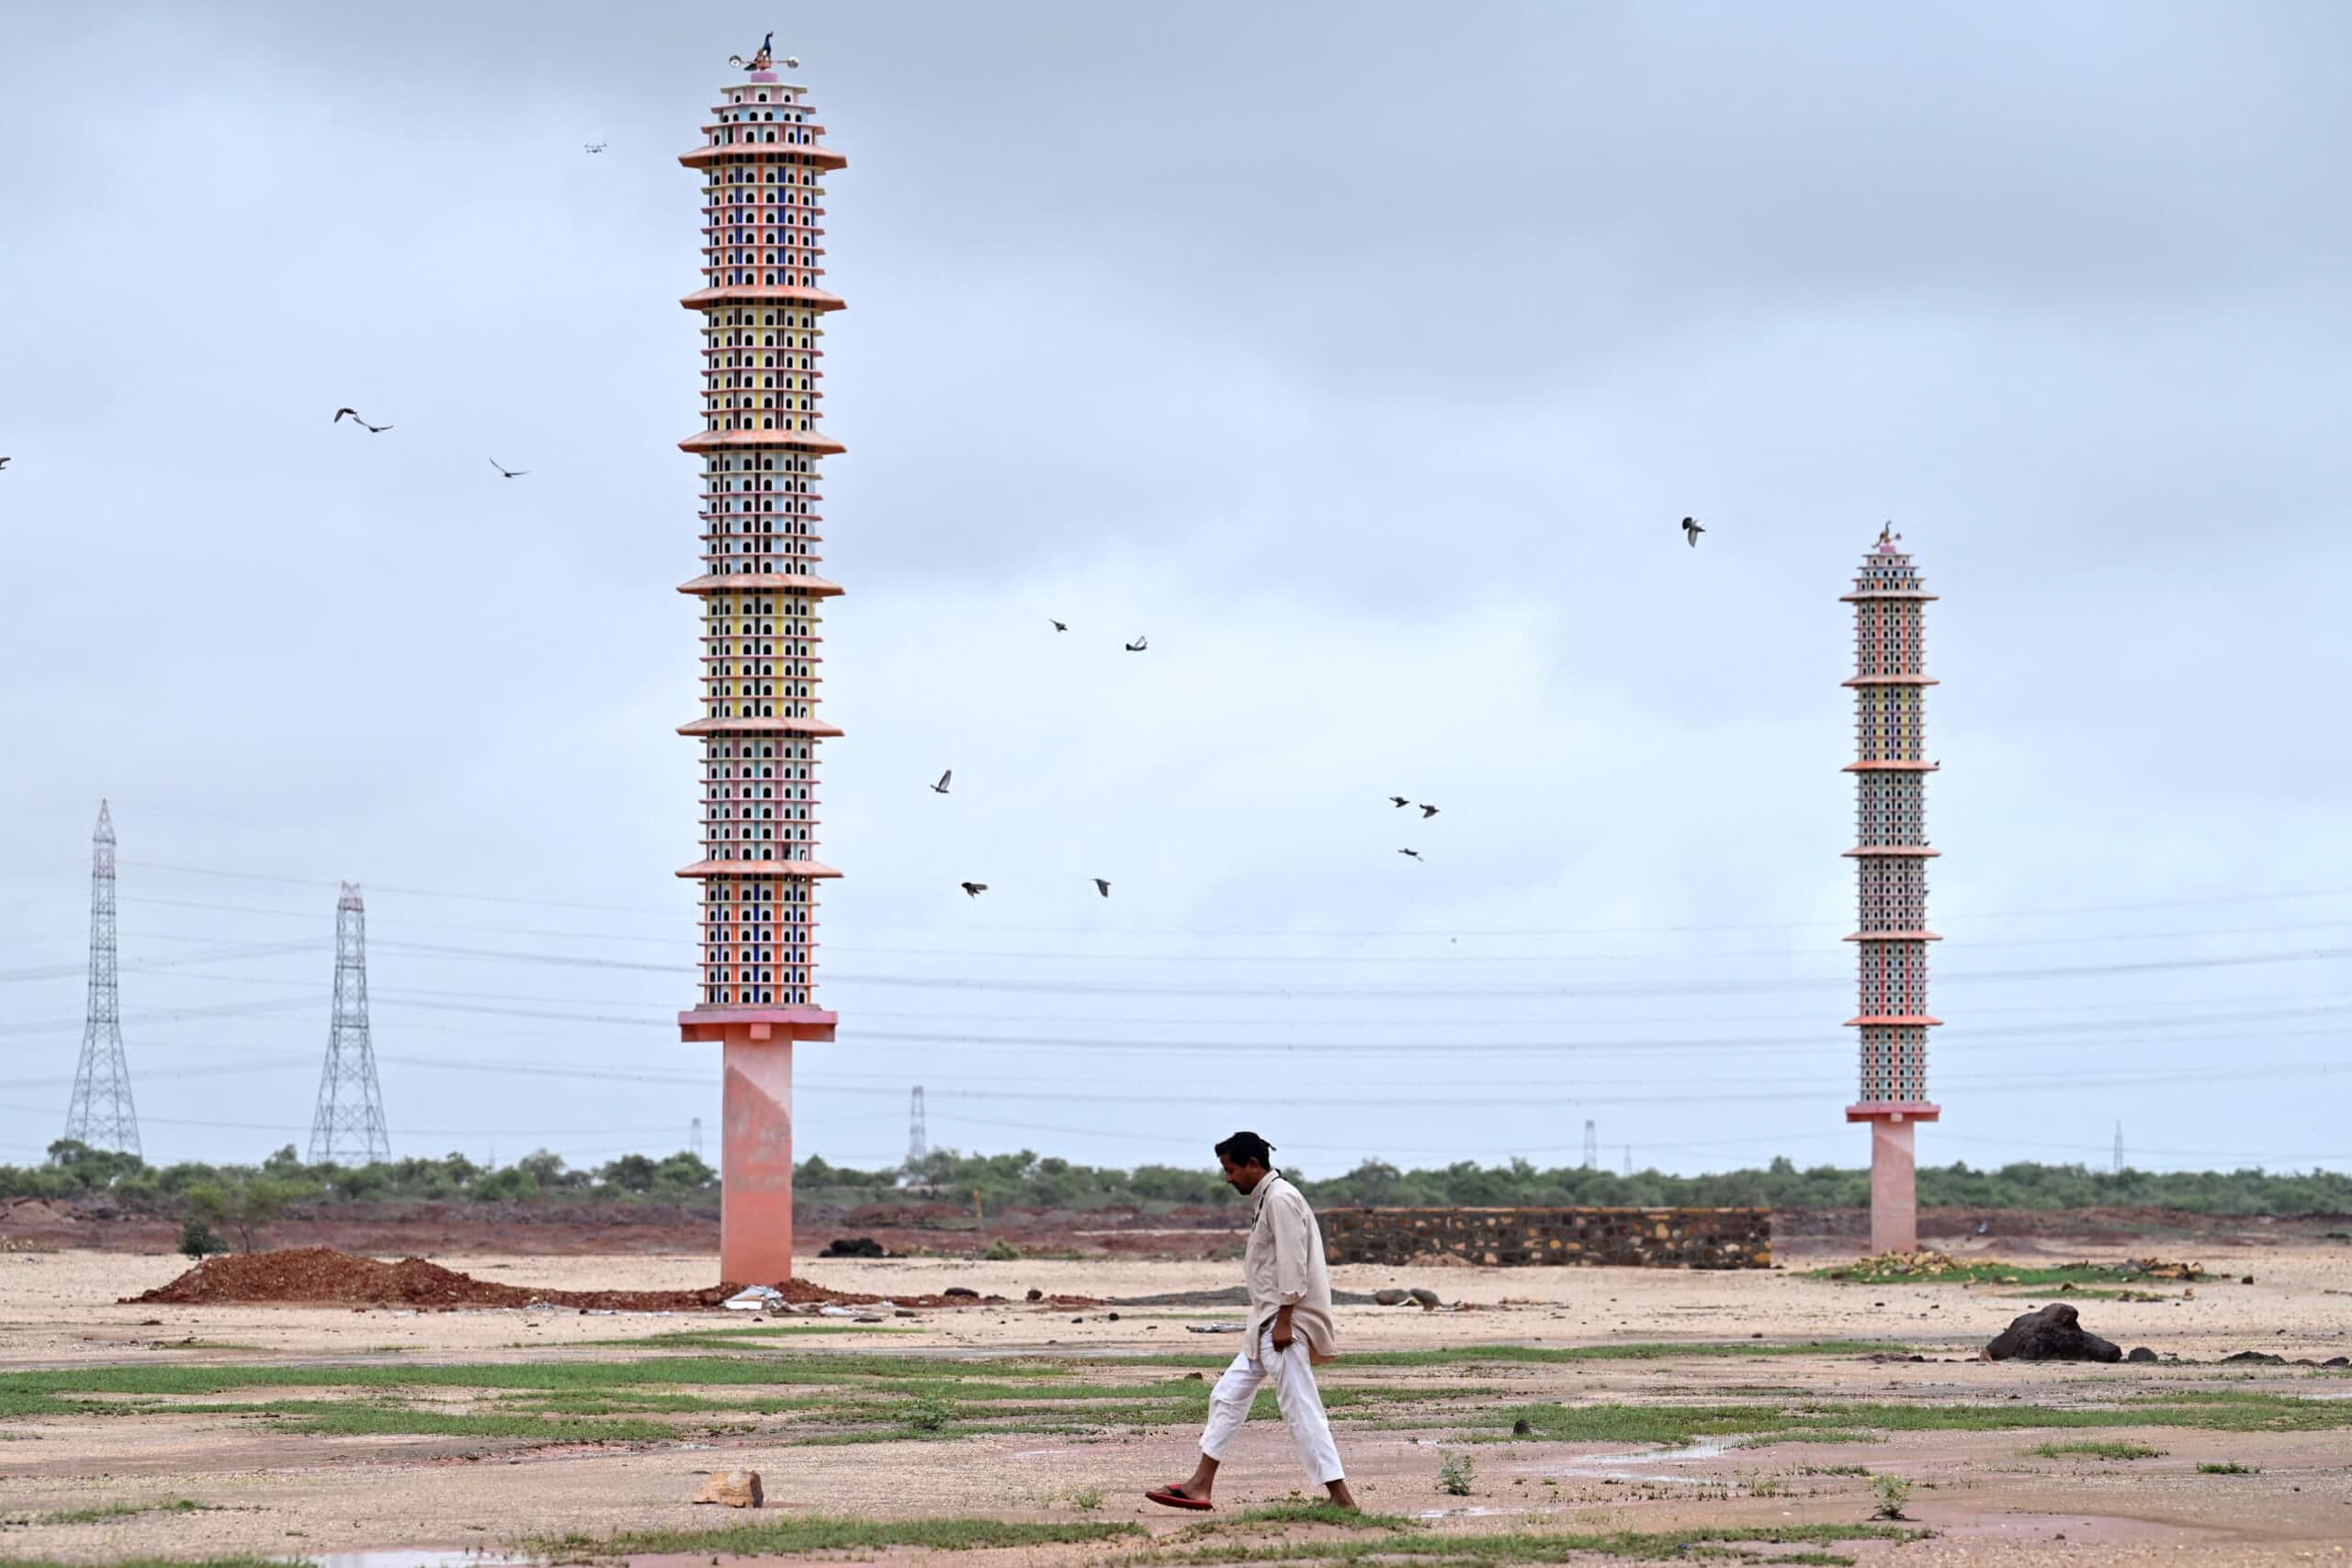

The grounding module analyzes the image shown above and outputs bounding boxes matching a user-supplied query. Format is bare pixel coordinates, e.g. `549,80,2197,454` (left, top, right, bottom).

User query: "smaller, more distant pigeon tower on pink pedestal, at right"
1844,525,1943,1253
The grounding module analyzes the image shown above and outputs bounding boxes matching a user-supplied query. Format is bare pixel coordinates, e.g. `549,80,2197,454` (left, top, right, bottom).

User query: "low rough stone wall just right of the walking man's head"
1315,1208,1771,1269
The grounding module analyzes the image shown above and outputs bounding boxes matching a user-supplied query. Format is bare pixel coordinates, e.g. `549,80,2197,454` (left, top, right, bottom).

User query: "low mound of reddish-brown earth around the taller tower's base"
122,1246,926,1312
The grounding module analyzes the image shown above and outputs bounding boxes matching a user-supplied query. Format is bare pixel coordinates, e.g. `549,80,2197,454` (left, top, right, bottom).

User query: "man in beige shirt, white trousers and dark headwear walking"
1143,1134,1355,1509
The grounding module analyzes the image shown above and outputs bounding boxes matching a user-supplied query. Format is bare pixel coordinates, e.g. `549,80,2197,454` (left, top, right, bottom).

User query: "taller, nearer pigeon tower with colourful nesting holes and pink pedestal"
677,45,849,1283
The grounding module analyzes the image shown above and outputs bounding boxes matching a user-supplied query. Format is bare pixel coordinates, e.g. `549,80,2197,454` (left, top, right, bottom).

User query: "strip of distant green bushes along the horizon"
0,1140,2352,1235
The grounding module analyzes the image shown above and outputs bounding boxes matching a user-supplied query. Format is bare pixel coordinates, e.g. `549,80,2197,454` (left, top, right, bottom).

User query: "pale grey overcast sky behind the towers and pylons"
0,0,2352,1173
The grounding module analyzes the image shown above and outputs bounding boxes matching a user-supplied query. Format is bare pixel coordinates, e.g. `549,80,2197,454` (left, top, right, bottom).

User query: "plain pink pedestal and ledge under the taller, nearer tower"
677,1006,837,1286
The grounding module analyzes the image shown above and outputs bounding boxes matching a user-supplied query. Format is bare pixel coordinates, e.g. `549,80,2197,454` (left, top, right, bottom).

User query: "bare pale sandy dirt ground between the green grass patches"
0,1236,2352,1568
